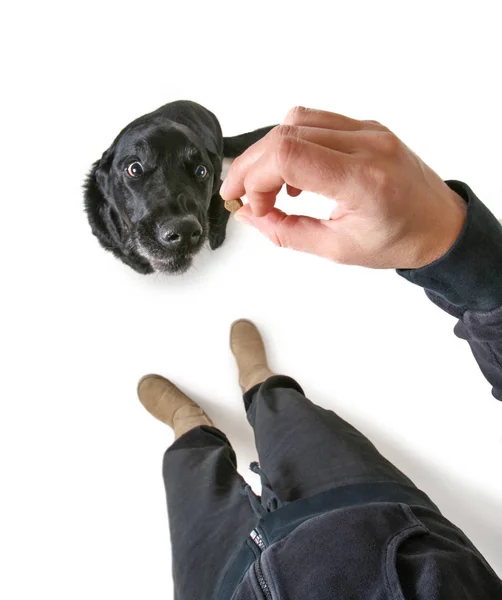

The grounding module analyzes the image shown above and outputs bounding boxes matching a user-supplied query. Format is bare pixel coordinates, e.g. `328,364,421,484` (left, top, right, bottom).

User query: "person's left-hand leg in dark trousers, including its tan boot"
138,376,257,600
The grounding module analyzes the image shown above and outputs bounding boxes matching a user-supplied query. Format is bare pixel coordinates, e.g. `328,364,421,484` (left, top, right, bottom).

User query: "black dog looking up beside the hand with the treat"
84,100,272,273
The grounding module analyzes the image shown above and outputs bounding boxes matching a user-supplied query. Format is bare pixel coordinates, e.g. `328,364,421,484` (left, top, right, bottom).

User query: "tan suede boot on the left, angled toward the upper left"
138,375,214,439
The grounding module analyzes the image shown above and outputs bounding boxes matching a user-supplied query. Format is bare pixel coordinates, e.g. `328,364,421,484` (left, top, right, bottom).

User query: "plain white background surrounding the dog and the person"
0,0,502,600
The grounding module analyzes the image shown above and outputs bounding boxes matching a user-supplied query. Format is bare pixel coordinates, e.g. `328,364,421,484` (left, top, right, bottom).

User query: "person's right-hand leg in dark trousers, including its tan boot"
230,321,413,504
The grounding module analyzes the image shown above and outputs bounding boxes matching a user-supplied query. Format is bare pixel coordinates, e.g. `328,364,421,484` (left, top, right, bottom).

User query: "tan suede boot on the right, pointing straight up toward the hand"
230,319,275,392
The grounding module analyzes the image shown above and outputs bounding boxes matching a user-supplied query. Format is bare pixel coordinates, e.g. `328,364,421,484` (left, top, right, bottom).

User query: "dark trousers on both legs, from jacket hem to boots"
163,376,413,600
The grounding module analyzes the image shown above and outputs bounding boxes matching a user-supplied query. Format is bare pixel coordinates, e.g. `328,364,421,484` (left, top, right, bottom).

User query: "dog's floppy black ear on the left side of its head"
84,146,153,273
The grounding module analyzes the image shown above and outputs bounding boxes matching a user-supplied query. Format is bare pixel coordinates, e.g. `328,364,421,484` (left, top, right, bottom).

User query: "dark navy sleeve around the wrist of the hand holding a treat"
397,181,502,400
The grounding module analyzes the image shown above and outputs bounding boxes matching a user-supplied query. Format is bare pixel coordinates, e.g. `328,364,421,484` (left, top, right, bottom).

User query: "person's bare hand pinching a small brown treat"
220,107,466,269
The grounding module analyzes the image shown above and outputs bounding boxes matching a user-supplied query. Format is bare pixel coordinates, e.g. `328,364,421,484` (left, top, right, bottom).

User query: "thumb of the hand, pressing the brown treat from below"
235,204,336,258
